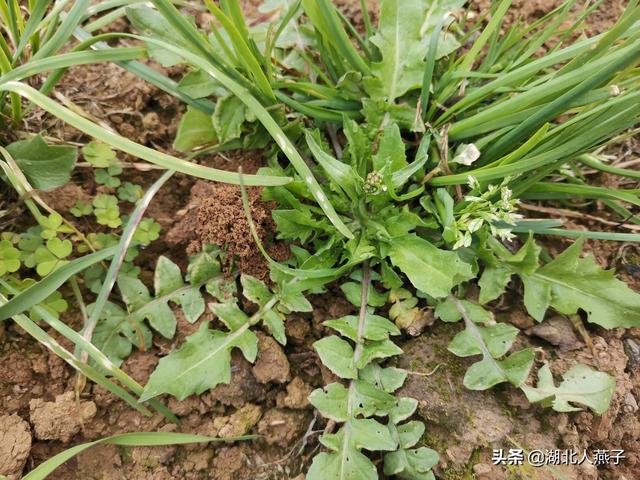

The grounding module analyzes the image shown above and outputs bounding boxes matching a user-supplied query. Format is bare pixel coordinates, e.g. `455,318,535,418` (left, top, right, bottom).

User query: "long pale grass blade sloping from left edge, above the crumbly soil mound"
0,82,288,186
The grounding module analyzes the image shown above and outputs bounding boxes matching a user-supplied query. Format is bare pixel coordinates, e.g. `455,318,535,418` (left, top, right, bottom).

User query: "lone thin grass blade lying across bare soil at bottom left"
22,432,256,480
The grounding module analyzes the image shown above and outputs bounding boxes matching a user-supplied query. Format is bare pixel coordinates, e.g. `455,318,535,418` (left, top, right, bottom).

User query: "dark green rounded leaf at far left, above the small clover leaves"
7,135,78,190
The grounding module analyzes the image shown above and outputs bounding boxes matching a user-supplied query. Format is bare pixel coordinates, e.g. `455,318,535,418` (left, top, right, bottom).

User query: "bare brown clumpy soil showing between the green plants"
0,0,640,480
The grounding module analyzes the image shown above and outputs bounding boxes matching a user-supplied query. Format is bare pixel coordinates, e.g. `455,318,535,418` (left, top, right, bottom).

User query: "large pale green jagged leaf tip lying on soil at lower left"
140,323,258,401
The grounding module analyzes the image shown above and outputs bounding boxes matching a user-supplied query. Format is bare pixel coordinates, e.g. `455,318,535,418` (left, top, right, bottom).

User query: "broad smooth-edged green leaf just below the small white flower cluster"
389,235,474,298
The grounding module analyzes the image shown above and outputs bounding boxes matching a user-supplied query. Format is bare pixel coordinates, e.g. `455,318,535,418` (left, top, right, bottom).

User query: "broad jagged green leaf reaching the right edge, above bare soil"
523,241,640,329
